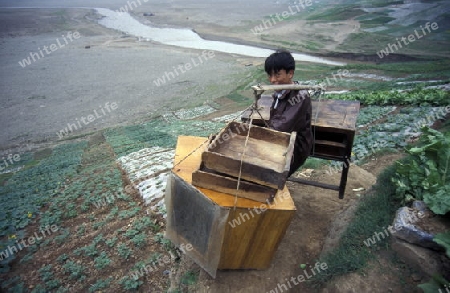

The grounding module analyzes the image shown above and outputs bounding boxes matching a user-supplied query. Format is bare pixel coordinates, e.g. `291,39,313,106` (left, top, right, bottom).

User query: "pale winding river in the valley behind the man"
96,8,345,66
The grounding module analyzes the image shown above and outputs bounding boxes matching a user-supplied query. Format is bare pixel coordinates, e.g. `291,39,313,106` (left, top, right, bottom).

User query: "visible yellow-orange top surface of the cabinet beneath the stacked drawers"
172,136,296,211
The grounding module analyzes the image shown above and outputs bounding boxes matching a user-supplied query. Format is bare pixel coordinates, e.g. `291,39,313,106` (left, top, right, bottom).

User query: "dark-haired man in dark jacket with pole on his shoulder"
264,50,313,176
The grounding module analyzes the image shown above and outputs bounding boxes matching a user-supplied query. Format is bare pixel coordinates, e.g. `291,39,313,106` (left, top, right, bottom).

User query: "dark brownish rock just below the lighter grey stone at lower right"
391,237,443,277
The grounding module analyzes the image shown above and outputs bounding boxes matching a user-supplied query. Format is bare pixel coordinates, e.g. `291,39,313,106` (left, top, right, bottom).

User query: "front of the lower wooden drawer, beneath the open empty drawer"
192,170,277,202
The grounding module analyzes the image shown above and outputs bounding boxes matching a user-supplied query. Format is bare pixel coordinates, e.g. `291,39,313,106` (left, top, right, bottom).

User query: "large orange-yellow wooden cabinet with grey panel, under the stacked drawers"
166,136,296,277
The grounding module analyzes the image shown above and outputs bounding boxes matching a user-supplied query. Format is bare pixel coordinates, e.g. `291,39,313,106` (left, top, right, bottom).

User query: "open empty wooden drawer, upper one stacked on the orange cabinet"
202,122,296,189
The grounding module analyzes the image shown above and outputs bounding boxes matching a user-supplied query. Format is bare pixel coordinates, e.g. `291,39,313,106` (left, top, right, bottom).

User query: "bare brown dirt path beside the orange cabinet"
177,154,414,293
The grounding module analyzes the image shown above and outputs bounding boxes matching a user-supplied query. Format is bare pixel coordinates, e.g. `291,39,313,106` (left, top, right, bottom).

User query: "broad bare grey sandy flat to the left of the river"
0,9,258,149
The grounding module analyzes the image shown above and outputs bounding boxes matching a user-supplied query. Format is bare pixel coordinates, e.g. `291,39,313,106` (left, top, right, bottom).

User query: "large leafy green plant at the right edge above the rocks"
392,127,450,215
